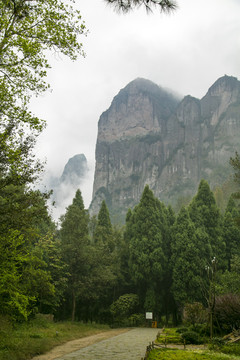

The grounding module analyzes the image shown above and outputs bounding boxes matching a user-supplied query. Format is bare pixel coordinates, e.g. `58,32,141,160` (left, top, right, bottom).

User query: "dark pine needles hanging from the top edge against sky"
105,0,177,12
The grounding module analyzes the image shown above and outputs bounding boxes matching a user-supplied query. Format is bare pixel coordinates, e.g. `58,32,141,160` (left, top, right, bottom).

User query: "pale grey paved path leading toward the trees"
56,328,159,360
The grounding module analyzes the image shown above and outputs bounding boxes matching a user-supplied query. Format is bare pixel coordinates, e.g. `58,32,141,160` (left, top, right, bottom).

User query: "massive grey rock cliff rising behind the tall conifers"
90,76,240,219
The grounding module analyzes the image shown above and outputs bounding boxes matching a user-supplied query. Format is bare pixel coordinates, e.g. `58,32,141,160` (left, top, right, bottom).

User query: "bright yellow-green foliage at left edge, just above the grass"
0,230,57,320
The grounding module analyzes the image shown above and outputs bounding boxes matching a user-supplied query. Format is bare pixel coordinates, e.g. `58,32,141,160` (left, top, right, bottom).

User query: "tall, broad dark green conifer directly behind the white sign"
125,186,166,313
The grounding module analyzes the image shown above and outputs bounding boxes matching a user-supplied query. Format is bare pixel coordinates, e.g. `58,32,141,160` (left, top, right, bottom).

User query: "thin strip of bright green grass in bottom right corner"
148,349,240,360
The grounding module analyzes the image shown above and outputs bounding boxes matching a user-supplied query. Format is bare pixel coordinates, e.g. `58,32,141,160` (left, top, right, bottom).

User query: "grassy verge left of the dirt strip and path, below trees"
0,319,109,360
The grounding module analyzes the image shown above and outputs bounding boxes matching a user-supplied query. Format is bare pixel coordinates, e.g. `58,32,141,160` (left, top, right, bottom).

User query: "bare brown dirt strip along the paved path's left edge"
32,329,129,360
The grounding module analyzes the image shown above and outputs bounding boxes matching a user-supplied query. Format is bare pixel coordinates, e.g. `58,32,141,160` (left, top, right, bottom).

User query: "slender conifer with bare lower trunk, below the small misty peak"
59,190,89,321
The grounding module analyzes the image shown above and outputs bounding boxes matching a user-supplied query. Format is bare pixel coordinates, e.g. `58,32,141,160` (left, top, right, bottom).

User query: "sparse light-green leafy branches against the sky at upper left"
0,0,85,188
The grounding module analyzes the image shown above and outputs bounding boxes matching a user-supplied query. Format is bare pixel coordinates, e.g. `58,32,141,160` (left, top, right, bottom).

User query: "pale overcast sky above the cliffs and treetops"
32,0,240,217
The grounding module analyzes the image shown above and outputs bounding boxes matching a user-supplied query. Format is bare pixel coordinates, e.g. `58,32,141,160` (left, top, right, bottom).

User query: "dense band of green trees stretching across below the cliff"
0,166,240,330
